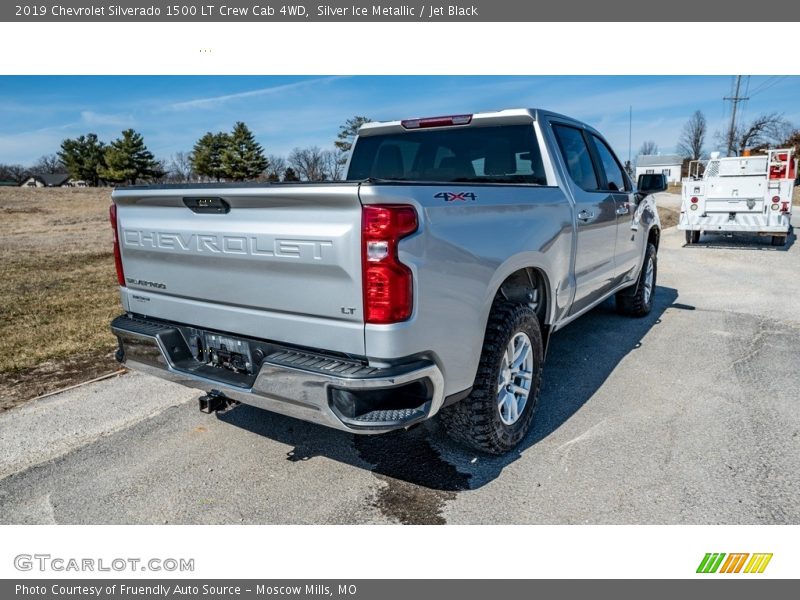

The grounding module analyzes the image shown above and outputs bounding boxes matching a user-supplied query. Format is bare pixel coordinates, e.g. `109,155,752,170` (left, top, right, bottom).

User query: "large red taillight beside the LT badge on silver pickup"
361,205,418,324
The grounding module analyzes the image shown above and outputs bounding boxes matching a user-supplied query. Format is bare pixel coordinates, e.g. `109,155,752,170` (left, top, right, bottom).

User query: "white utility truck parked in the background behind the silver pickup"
678,148,797,246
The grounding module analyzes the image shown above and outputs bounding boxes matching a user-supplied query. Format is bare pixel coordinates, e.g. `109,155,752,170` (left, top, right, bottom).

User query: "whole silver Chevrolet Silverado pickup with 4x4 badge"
111,109,665,454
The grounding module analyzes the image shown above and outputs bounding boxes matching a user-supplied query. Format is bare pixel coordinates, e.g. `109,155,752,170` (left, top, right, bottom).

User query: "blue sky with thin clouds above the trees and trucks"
0,76,800,165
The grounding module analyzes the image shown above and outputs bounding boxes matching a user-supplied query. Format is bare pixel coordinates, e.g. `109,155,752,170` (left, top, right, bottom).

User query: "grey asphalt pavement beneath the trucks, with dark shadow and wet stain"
0,218,800,524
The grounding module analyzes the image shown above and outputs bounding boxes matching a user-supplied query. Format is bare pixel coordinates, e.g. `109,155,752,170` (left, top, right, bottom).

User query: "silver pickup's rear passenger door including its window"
552,122,617,314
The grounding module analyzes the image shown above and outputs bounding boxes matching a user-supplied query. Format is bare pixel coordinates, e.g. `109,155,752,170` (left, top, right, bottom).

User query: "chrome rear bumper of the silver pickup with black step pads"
111,315,444,433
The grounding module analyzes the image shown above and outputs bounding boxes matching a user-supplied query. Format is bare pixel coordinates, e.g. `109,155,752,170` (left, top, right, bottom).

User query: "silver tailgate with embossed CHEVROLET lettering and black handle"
113,184,364,354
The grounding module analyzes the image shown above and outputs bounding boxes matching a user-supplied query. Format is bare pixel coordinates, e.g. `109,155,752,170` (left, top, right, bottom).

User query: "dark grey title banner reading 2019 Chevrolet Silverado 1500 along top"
6,0,800,21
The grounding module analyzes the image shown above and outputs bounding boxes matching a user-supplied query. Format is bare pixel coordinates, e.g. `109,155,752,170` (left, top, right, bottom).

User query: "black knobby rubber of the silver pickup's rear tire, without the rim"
440,302,544,454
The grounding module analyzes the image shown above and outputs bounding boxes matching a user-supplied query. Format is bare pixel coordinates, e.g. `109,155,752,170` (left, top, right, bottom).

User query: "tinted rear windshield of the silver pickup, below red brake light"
347,125,547,185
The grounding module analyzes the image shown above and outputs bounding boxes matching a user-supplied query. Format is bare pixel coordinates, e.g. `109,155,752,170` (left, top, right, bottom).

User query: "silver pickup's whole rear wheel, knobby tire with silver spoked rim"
441,302,544,454
